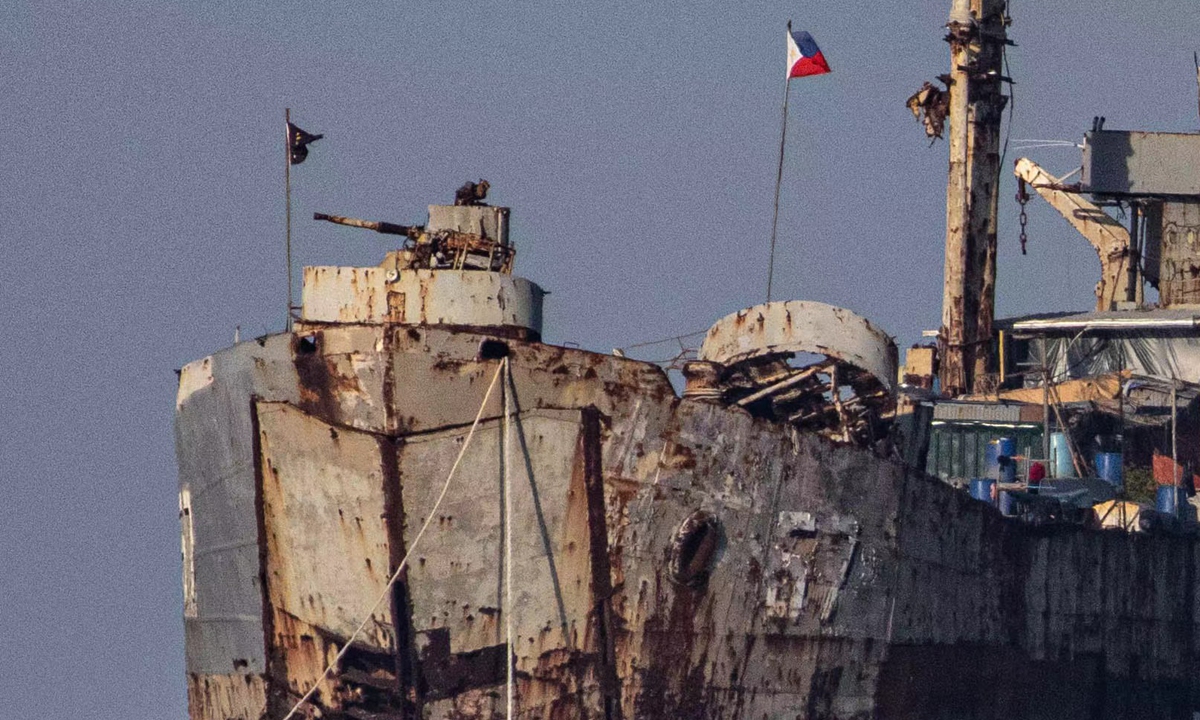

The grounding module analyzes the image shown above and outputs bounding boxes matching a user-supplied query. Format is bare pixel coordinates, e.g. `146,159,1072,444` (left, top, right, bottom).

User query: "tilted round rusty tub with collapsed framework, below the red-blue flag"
684,300,896,443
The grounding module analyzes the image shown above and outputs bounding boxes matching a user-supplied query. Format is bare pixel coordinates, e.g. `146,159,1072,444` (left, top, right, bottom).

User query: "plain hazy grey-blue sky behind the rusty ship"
0,0,1200,719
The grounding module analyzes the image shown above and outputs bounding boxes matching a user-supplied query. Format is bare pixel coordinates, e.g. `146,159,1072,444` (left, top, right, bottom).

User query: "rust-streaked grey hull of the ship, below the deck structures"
176,309,1200,720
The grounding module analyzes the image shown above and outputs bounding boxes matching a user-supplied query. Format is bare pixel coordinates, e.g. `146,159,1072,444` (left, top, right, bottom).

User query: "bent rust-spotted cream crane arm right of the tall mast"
1013,157,1129,311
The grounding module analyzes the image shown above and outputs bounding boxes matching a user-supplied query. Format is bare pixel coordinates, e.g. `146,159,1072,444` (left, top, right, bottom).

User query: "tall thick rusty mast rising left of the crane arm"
938,0,1009,397
